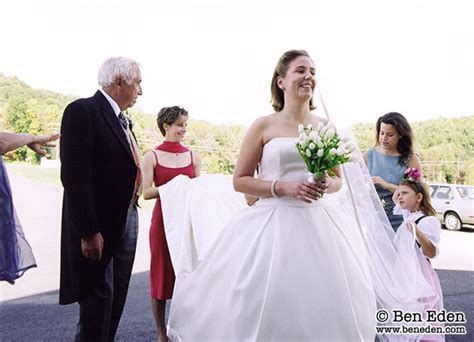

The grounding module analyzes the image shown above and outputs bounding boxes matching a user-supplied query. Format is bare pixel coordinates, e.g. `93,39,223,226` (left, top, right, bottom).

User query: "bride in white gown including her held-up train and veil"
160,50,439,341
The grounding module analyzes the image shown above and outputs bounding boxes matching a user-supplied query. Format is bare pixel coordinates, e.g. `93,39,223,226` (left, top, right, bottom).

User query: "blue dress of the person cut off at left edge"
0,156,36,284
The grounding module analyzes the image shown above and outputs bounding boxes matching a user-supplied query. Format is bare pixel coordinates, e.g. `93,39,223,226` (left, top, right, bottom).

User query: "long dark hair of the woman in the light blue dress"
375,112,413,165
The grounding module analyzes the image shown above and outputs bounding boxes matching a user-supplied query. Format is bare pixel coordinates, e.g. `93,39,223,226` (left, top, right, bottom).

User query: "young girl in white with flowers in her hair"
393,168,444,341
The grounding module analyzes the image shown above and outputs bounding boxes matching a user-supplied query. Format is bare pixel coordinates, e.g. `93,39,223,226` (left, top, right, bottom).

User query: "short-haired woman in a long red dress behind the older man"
142,106,201,341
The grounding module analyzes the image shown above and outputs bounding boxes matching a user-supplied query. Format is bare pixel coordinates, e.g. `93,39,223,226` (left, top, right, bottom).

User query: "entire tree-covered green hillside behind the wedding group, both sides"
0,73,474,184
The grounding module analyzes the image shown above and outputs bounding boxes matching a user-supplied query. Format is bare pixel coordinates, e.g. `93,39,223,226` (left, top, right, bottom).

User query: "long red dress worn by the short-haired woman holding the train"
150,151,194,300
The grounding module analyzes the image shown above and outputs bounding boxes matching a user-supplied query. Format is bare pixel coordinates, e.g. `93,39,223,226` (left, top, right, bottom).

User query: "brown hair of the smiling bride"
270,50,316,112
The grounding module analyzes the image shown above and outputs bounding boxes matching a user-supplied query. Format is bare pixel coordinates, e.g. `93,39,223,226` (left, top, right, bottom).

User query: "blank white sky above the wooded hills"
0,0,474,125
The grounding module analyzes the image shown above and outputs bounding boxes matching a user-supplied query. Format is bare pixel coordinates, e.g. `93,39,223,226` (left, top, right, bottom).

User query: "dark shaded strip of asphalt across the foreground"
0,270,474,341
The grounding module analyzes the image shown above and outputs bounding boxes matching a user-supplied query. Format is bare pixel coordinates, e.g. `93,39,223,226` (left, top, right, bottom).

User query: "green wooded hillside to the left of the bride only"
0,73,245,173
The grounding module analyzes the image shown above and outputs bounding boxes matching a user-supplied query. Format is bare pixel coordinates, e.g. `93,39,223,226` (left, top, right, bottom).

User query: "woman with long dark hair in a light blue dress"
364,112,423,231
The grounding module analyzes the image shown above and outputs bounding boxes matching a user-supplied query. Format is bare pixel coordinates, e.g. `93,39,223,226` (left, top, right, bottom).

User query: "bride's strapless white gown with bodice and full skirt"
164,138,376,341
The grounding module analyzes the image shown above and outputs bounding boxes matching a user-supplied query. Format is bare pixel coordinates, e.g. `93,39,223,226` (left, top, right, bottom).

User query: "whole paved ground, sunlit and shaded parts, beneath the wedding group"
0,175,474,341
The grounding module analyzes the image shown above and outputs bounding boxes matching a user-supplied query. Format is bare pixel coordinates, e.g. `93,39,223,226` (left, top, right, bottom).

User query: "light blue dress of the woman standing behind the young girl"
367,148,406,231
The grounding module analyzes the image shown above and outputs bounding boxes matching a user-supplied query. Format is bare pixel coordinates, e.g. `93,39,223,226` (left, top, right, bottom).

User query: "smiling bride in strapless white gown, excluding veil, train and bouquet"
164,50,376,341
